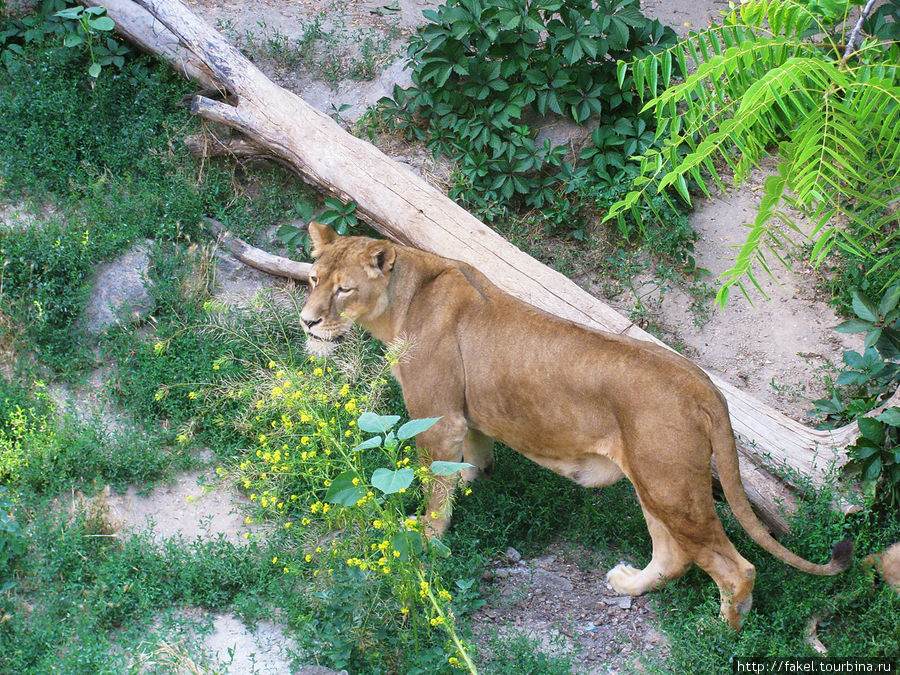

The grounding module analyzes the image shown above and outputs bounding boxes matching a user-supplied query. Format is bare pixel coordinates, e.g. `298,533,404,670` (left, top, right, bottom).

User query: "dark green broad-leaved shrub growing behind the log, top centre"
372,0,675,243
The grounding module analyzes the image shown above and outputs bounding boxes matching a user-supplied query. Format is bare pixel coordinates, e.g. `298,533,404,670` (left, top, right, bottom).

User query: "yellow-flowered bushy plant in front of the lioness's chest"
184,301,471,672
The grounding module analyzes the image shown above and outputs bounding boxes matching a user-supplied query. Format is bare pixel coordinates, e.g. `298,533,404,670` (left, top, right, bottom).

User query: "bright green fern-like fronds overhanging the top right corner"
607,0,900,305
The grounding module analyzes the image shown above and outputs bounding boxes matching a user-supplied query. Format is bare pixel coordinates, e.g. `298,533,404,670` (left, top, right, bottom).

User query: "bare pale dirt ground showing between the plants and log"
8,0,859,673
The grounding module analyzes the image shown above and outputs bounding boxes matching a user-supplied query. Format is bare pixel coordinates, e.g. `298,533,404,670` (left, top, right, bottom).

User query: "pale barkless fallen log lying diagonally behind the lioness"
88,0,858,531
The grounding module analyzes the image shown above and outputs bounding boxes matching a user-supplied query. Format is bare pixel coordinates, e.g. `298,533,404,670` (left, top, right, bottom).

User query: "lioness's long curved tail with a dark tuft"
710,399,853,576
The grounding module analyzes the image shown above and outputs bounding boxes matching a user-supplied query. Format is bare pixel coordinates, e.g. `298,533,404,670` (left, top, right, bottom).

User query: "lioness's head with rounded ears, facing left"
300,222,396,356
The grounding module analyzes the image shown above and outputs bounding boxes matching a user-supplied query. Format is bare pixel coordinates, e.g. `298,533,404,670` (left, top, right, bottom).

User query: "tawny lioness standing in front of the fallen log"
301,222,852,630
